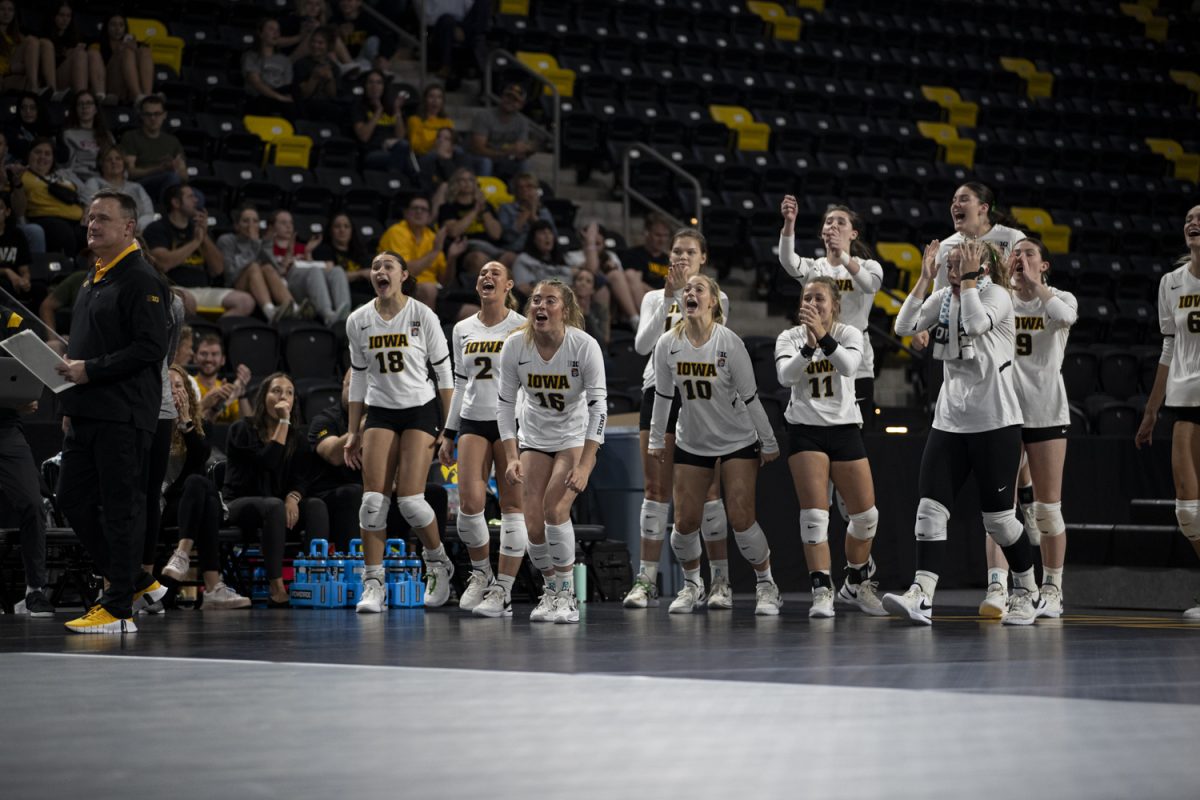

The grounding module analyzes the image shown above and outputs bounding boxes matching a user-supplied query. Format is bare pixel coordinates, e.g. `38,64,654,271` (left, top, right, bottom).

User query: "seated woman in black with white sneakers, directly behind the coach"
162,366,250,610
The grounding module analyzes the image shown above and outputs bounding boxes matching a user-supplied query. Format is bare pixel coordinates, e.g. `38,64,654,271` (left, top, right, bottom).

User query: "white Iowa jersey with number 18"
346,297,450,409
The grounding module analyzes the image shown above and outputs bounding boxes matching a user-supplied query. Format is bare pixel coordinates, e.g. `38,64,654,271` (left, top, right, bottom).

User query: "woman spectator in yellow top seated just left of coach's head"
18,139,84,255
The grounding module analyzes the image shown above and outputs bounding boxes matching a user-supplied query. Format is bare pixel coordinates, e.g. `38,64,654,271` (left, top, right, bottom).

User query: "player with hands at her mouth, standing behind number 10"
623,228,733,608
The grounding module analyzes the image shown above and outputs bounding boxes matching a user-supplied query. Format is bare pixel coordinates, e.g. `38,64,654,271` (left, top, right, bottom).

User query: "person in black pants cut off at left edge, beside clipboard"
0,299,54,616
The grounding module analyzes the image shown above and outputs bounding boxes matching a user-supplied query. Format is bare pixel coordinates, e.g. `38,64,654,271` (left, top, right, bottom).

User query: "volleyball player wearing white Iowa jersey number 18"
344,251,454,614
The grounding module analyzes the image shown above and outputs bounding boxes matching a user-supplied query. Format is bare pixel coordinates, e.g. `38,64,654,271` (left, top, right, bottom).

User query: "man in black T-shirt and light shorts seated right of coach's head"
145,184,254,317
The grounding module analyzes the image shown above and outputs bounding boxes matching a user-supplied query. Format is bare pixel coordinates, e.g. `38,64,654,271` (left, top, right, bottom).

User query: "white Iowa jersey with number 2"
446,311,524,431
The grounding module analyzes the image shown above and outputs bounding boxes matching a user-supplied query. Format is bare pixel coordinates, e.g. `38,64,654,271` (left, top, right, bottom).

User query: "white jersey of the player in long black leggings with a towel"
895,283,1024,433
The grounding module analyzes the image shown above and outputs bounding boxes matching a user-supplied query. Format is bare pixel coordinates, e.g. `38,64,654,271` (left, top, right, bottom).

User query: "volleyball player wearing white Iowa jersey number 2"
439,261,528,616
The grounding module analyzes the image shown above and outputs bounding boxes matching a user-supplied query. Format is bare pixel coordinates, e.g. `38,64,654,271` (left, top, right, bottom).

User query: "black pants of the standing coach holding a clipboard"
58,417,154,619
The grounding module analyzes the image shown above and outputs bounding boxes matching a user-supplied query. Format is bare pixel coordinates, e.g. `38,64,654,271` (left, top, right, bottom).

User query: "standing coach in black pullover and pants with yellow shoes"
58,190,169,633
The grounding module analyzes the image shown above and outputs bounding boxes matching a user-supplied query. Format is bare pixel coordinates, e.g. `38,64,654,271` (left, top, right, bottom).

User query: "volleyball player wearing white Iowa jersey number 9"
979,239,1079,618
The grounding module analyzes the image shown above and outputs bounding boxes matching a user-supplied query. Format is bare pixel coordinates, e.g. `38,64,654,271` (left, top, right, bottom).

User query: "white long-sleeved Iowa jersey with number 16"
497,327,608,453
